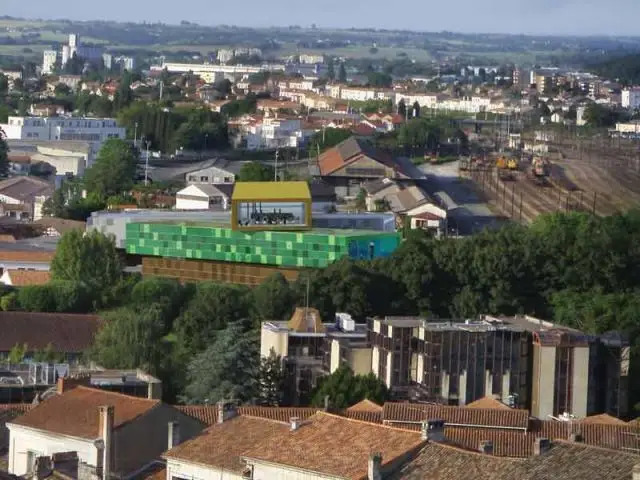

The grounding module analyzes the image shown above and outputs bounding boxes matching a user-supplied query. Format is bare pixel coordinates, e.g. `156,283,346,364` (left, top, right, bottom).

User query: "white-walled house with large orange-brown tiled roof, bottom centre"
164,411,425,480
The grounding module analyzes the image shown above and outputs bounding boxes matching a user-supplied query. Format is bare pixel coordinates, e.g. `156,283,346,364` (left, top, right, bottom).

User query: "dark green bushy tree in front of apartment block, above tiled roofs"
312,364,388,409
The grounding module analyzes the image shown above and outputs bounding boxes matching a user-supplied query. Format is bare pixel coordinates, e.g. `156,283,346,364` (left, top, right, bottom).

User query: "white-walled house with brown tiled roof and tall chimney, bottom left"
7,386,203,480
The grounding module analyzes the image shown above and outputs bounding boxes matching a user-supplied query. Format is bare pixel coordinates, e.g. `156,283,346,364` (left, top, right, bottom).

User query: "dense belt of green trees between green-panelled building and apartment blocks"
1,211,640,403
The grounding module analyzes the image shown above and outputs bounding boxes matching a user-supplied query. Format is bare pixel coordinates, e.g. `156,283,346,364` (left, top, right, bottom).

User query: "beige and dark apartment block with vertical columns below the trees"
262,316,629,418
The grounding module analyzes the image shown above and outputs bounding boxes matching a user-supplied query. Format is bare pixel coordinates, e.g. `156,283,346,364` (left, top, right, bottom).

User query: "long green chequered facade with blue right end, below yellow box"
126,223,400,267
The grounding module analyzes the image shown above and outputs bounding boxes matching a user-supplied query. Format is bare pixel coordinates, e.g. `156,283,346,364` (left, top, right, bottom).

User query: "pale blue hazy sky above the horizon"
0,0,640,35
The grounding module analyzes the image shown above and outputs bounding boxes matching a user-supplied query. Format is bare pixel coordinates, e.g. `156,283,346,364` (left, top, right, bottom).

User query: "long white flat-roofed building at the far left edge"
0,117,126,160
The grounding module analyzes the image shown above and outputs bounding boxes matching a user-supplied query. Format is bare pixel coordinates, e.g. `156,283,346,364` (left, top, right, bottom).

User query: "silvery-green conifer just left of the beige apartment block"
184,321,260,404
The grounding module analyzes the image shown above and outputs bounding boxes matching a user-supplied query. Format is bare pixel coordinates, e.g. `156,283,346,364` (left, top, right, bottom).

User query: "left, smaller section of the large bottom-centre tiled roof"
163,415,289,473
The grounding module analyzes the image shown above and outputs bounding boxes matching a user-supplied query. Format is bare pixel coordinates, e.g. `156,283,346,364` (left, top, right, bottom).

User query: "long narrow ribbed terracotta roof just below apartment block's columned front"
383,402,529,430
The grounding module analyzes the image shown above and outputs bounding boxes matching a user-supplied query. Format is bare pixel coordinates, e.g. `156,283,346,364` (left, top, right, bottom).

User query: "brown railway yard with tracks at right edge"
460,142,640,223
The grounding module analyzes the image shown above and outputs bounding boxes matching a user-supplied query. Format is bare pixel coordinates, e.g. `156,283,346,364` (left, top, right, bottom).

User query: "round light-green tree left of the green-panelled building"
51,230,123,292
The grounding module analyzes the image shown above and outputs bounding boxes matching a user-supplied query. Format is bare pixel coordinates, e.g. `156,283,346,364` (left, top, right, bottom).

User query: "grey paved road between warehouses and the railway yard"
420,162,505,235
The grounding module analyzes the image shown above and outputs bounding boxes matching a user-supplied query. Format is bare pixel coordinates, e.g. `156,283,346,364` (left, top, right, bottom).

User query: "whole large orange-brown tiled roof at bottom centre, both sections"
164,412,424,479
